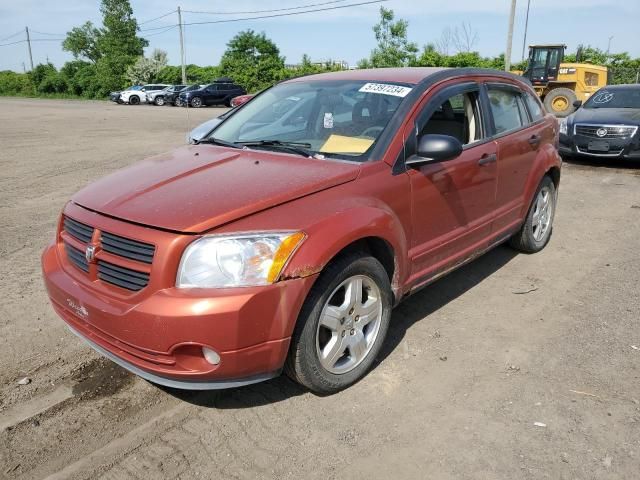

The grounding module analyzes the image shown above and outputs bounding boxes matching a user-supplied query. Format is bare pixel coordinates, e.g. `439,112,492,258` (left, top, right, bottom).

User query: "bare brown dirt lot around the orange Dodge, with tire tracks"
0,99,640,480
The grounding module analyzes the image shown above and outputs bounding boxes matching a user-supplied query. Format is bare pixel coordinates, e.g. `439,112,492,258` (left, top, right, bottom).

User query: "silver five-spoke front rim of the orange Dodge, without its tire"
316,275,382,375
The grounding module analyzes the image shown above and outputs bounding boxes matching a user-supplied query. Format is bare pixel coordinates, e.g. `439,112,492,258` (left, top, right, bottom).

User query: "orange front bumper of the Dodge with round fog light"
42,208,315,389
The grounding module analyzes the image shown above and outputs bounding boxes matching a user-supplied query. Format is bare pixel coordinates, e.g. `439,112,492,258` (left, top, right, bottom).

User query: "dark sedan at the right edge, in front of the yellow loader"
560,85,640,160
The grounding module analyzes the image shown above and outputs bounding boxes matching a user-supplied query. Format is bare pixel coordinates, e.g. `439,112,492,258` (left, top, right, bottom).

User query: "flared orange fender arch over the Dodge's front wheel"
281,206,407,298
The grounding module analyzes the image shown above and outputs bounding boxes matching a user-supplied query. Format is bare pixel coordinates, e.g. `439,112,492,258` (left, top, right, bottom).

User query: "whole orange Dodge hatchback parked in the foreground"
42,68,561,393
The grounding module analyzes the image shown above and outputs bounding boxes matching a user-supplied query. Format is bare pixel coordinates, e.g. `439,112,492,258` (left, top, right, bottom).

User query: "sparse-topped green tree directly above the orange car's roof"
359,7,418,68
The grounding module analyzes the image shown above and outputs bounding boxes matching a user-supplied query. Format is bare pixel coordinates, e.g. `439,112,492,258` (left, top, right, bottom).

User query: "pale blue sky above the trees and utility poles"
0,0,640,71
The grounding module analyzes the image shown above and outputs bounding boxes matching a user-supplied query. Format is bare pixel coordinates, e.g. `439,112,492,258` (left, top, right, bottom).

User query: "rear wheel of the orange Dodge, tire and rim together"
509,175,558,253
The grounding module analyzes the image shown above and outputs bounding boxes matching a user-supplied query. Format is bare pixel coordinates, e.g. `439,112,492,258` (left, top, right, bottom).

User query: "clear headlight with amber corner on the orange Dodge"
176,232,305,288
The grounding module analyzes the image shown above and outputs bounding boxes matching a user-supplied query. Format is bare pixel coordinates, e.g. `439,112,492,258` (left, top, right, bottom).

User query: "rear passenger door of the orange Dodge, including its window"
487,83,542,232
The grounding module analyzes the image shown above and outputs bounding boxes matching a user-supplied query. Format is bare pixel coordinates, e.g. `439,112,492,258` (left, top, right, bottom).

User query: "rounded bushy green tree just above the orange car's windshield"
220,30,284,92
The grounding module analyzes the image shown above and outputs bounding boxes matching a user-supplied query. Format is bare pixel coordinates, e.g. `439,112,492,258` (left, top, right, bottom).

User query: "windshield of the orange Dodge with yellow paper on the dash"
209,81,411,161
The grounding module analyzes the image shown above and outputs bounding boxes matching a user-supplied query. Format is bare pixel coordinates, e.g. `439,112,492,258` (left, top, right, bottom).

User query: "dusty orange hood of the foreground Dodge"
72,145,360,233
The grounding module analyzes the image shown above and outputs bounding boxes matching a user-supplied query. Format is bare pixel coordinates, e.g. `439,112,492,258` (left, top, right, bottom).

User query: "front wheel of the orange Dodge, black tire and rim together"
285,252,392,394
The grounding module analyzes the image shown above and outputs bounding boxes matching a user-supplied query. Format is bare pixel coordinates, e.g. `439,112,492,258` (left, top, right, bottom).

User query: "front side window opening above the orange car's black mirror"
417,90,483,145
